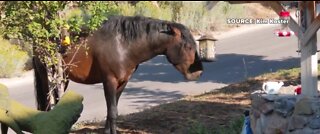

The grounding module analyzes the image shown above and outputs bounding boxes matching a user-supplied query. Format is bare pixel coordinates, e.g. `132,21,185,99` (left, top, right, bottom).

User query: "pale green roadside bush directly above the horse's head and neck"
168,1,248,32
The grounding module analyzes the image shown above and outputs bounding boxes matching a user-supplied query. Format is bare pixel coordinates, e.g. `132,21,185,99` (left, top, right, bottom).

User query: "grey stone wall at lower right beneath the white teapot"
250,93,320,134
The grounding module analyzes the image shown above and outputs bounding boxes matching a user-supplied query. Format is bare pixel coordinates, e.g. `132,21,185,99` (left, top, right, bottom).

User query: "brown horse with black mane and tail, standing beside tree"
34,16,203,134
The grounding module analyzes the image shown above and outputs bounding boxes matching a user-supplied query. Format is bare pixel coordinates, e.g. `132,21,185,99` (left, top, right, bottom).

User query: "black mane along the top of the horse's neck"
102,16,194,45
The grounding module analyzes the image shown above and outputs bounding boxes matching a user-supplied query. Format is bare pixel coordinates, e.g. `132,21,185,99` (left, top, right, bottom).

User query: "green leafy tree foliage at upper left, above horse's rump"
1,1,117,65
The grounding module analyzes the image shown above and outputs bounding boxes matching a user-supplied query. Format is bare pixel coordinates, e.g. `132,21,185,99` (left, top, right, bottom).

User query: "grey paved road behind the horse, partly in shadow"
4,23,300,124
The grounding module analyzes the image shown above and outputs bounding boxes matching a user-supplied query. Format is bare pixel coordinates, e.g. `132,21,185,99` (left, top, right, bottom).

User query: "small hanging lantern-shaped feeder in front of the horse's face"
197,35,217,62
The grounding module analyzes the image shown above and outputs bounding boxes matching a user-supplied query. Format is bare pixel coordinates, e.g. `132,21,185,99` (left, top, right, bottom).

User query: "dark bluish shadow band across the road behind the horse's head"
130,53,300,84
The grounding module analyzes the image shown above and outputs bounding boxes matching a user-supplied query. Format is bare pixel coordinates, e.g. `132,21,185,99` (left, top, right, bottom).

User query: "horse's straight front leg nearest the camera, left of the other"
103,79,118,134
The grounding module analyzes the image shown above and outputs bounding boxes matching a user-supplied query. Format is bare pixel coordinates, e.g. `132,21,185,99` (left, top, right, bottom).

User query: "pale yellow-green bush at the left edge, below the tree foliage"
0,38,28,78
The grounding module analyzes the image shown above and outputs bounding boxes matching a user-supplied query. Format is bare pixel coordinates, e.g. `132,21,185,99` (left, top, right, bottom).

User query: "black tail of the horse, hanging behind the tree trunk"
32,56,50,111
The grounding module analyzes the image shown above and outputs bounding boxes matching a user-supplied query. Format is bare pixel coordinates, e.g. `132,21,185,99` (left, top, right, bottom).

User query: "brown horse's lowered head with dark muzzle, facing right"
162,23,203,80
